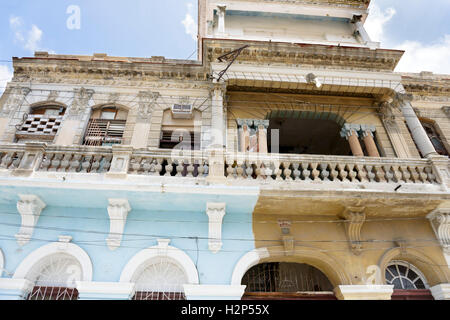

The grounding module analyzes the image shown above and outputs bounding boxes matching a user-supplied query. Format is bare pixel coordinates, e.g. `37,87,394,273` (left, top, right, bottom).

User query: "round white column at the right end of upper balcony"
397,94,437,157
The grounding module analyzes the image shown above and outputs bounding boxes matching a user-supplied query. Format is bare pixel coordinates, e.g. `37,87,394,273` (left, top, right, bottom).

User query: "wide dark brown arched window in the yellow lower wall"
242,262,335,299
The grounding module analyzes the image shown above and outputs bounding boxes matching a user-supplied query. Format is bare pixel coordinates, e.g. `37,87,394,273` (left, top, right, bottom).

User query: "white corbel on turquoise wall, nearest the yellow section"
206,202,226,253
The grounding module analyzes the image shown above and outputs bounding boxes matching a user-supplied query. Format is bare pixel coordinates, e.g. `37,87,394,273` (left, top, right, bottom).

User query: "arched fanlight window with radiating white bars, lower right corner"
385,261,433,300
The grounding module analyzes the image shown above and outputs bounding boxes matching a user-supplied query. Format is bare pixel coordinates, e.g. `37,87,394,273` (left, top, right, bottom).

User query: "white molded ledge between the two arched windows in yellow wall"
334,285,394,300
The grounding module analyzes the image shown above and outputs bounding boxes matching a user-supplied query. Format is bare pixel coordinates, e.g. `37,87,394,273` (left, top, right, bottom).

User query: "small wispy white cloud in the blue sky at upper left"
9,16,50,53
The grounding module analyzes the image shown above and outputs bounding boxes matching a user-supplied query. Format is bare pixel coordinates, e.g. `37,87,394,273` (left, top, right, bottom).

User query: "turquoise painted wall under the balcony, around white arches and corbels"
0,187,257,284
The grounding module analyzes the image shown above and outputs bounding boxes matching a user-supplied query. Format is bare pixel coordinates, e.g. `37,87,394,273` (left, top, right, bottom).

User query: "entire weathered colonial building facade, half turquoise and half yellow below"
0,0,450,300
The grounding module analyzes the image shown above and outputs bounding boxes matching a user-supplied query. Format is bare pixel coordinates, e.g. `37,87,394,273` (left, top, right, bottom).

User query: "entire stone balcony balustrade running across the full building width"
0,143,450,186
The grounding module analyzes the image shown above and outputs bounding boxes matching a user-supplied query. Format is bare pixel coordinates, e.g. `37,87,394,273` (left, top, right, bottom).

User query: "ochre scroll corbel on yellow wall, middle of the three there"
342,207,366,255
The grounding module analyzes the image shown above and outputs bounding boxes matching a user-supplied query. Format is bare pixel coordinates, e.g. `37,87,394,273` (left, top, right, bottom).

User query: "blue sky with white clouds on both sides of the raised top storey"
0,0,450,91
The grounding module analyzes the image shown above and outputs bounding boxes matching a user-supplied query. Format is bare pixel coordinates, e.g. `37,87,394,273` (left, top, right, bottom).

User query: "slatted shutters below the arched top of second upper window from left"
84,119,126,146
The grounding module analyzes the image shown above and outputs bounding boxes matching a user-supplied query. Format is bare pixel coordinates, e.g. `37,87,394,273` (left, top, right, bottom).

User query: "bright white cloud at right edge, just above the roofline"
395,34,450,74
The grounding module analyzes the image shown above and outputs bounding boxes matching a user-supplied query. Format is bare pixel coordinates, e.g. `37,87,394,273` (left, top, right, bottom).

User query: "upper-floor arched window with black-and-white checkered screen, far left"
16,104,66,142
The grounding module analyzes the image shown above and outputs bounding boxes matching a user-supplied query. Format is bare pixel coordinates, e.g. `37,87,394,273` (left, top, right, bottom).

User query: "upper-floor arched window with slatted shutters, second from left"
83,106,128,146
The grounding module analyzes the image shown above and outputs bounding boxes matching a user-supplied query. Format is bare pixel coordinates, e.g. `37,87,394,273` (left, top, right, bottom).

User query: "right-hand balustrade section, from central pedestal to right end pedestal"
225,154,437,184
